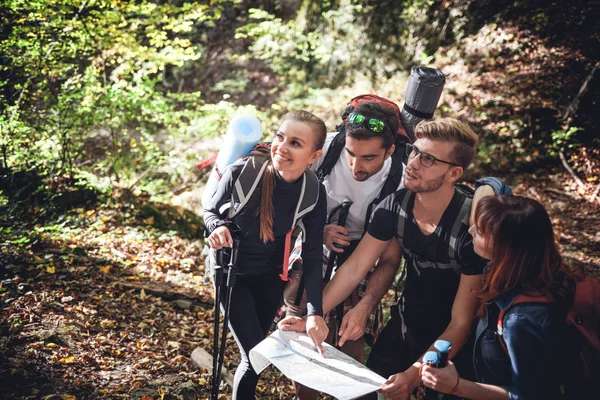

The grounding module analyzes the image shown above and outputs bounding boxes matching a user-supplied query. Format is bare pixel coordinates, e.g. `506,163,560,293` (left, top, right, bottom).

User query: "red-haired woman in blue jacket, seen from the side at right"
422,196,572,399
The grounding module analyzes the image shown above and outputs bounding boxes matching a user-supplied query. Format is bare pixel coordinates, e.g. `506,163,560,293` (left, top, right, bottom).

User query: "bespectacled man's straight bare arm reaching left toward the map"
323,233,395,313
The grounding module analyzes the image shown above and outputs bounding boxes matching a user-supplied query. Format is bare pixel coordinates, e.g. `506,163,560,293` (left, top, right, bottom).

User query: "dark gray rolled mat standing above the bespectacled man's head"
400,67,446,141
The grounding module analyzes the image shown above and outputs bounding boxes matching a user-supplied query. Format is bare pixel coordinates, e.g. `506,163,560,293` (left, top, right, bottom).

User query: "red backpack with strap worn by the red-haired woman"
498,276,600,398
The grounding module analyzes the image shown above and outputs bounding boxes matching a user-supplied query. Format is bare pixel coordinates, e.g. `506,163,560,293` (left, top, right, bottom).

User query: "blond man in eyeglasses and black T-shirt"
281,118,510,399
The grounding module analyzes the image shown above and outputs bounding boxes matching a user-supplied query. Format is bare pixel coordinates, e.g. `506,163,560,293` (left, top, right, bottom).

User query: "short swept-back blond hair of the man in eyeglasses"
415,118,479,169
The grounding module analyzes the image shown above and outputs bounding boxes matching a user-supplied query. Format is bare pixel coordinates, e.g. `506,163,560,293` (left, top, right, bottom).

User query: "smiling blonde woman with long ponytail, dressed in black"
204,111,328,400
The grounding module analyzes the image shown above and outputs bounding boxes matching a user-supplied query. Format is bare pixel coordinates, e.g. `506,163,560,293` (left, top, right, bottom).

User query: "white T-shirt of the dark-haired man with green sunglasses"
311,132,404,240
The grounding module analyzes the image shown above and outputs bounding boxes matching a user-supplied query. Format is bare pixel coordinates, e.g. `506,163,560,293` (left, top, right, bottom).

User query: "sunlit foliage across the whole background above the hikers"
0,0,594,200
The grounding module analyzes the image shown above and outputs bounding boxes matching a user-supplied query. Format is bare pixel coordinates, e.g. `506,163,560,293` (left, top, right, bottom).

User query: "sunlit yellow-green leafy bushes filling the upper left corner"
0,0,229,194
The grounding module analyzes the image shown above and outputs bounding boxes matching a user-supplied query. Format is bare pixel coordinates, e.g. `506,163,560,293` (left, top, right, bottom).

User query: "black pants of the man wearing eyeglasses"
362,306,474,400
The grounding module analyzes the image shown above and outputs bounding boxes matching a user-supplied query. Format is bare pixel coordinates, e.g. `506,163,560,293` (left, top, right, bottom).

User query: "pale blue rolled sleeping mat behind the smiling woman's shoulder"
202,114,263,207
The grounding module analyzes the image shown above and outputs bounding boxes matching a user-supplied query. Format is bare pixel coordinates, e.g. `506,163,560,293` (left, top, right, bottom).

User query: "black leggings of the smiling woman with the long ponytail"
221,270,285,400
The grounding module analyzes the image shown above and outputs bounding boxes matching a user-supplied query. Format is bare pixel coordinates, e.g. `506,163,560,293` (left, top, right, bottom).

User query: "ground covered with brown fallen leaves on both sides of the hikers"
0,170,600,400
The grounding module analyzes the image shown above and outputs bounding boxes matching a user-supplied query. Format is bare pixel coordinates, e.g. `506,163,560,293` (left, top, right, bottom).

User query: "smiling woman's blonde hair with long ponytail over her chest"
260,110,327,243
